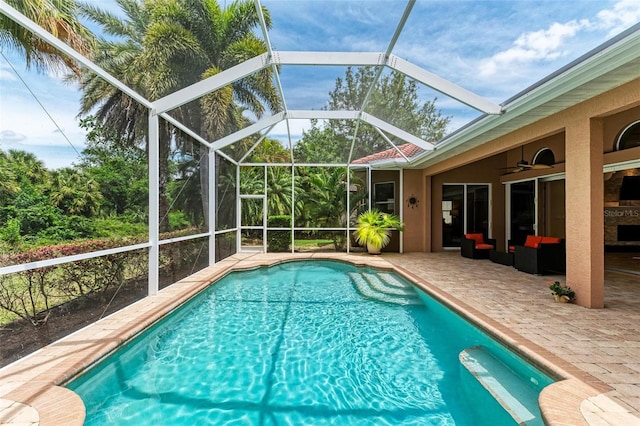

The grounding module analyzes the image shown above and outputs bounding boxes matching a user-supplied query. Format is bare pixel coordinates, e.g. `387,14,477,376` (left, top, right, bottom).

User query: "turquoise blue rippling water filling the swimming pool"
68,261,552,426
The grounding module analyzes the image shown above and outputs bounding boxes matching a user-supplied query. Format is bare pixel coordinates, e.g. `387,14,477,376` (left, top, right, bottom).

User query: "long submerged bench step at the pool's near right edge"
459,346,541,425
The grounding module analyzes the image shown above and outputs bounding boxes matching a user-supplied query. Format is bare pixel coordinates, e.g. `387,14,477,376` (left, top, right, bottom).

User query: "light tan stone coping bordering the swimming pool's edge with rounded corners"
0,253,640,426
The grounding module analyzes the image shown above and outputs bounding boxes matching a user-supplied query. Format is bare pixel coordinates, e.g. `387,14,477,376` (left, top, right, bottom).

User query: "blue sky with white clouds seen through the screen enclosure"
0,0,640,168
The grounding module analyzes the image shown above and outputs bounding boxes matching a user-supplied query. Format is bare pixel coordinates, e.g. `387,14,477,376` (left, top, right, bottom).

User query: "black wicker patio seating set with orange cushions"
460,233,566,275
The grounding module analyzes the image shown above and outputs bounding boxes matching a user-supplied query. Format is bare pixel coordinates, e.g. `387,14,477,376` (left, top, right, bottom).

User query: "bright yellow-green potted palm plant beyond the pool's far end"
353,209,404,254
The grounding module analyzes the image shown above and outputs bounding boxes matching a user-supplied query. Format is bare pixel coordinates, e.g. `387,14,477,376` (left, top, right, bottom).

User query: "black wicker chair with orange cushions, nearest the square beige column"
513,235,566,275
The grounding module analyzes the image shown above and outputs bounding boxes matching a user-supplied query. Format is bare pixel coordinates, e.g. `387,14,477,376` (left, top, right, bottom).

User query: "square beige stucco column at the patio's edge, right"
565,116,604,308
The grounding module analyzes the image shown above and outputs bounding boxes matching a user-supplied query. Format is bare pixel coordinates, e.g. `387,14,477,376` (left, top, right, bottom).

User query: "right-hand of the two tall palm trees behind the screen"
179,0,281,226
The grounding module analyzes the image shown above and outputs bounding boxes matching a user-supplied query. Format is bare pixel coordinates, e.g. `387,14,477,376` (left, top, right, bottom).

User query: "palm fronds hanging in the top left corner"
0,0,93,75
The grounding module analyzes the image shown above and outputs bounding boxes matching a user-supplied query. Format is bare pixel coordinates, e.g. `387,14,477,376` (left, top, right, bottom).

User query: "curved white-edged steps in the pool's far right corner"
349,272,422,305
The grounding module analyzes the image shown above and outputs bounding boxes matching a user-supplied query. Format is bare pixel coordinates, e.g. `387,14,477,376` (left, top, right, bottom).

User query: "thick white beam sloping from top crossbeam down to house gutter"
387,55,502,114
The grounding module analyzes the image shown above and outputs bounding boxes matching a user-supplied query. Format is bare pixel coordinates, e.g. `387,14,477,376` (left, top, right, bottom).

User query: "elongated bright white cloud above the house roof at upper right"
480,20,591,76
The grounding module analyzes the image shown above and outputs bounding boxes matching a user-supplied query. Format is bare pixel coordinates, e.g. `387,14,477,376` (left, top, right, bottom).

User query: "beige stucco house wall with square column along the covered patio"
404,79,640,308
